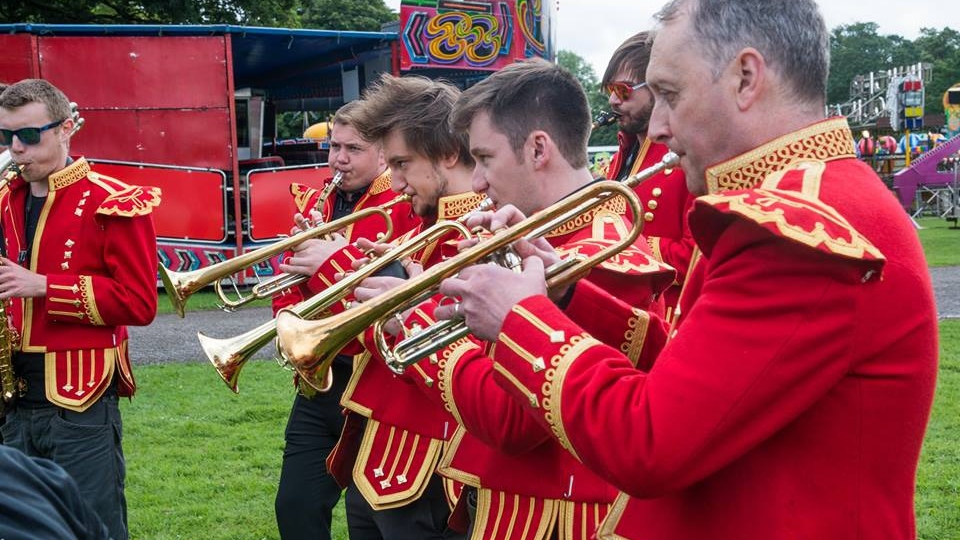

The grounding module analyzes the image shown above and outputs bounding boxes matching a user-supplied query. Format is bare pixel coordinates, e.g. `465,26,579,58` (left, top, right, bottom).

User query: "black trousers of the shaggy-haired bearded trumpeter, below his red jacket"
346,474,466,540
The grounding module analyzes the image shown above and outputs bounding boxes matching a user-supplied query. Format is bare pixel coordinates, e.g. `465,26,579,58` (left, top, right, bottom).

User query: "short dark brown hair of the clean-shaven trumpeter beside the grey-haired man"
453,58,591,169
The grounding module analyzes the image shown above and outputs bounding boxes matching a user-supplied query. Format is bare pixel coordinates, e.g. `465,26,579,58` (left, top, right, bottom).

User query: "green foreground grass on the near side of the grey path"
122,320,960,540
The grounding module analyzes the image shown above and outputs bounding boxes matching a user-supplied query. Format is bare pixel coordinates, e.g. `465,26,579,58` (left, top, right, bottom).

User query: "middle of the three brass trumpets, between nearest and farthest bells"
197,221,472,393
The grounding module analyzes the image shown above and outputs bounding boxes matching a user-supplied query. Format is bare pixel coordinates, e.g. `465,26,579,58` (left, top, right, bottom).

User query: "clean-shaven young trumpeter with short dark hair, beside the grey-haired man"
390,60,673,540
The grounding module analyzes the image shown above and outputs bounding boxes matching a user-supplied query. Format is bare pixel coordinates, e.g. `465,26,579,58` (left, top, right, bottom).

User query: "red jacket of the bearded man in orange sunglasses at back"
607,131,694,314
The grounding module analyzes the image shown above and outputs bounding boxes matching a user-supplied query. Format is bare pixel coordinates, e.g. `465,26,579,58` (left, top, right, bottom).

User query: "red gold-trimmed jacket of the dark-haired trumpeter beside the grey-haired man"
394,200,674,540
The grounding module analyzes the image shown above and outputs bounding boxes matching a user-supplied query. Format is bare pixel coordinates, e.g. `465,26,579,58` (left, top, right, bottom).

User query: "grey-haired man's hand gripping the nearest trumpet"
434,255,547,342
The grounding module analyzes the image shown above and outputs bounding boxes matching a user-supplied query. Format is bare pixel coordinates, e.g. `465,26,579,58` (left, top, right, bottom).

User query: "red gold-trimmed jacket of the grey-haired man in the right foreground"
494,119,937,540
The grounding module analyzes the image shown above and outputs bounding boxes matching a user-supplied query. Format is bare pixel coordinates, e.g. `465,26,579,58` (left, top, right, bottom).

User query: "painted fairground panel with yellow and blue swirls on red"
400,0,556,71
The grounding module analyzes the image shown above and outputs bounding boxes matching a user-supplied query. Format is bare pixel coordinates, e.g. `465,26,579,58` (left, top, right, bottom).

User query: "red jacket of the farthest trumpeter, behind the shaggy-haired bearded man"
273,169,420,314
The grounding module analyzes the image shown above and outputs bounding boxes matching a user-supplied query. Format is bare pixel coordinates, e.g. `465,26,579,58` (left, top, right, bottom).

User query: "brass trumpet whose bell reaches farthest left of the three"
159,191,410,318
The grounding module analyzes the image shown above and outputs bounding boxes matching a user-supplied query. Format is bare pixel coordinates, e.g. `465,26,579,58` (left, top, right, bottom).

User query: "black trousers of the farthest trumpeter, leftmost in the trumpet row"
275,358,351,540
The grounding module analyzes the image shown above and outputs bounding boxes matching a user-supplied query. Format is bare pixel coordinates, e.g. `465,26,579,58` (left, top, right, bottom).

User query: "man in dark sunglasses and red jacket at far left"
0,79,160,540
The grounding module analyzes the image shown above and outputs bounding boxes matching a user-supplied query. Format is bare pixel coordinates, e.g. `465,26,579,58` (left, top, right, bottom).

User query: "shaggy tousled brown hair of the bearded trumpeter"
351,73,474,167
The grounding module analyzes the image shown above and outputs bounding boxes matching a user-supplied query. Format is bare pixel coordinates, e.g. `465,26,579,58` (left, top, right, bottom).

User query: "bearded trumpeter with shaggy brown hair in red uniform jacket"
280,75,483,540
